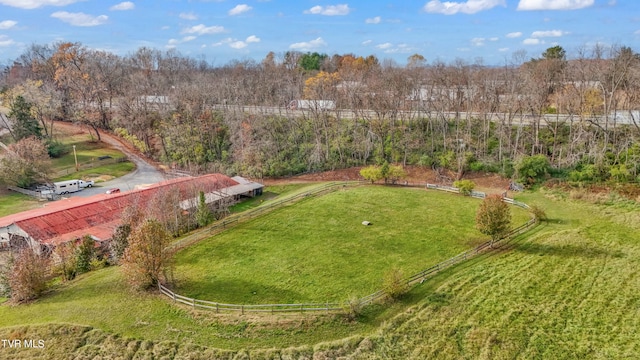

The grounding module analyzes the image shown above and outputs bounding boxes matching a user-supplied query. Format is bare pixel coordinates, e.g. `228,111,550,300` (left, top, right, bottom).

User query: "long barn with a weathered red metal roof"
0,174,263,250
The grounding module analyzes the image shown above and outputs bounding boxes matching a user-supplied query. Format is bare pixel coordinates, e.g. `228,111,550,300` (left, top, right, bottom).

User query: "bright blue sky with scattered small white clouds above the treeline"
0,0,640,65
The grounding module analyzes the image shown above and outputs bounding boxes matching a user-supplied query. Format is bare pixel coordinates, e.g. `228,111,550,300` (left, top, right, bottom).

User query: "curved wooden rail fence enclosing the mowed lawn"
158,182,536,314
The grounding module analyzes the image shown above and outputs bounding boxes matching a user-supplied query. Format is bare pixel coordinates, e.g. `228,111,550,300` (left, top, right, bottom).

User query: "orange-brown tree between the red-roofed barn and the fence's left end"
121,219,173,289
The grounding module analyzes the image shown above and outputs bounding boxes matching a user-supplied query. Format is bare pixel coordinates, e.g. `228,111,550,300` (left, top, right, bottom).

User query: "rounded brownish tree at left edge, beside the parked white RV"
0,137,51,188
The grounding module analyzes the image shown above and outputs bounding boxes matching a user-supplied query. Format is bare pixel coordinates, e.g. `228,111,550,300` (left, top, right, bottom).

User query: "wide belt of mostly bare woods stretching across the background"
2,43,640,183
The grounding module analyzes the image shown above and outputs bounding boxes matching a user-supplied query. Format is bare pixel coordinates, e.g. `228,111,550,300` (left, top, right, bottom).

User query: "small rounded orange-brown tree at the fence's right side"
476,194,511,247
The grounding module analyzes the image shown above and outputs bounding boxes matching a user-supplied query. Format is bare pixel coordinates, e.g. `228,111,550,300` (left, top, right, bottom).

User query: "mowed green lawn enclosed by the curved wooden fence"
175,186,529,304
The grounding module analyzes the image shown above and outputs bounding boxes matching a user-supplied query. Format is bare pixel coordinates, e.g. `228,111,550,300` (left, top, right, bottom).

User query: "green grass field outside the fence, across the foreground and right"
0,187,640,359
